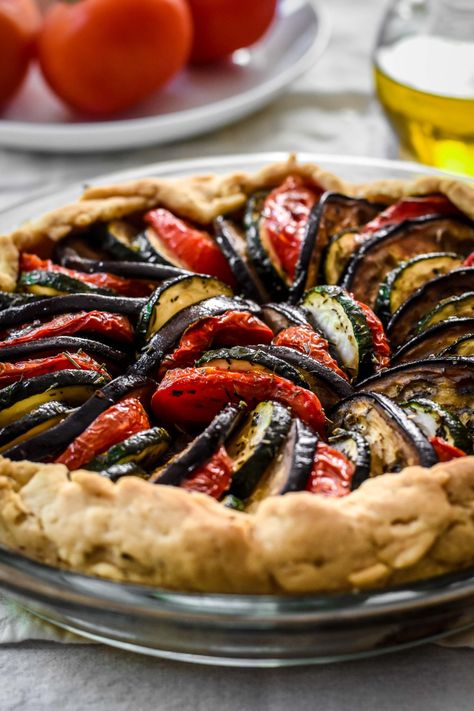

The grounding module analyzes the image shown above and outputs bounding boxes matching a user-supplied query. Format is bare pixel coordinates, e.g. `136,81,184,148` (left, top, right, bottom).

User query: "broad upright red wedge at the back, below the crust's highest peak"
262,176,322,280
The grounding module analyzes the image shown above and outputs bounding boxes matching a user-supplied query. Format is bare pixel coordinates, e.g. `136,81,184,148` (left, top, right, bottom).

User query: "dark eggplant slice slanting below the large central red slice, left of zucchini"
149,405,244,486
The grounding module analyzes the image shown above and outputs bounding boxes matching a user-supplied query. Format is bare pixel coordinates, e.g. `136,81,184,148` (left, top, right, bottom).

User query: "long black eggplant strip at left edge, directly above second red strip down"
0,294,146,329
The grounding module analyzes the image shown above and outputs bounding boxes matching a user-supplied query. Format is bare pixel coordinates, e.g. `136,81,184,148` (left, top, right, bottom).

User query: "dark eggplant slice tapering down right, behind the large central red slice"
258,346,353,409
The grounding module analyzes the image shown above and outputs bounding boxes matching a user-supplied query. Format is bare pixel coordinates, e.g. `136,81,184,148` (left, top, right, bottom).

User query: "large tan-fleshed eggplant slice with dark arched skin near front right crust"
331,392,438,476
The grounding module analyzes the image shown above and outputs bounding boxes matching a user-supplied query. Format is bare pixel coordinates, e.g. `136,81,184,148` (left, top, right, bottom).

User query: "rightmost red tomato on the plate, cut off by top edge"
188,0,277,64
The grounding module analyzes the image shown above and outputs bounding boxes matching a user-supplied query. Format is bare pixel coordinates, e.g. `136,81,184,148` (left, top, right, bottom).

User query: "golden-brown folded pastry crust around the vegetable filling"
0,156,474,594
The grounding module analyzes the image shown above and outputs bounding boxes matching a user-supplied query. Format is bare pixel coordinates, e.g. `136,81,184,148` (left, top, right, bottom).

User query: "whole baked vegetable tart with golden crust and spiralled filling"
0,156,474,594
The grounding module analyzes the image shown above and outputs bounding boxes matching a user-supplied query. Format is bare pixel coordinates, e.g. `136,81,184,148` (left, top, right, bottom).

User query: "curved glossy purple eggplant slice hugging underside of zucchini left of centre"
132,296,262,375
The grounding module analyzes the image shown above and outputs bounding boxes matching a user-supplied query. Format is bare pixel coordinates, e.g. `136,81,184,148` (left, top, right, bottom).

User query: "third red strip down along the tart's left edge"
0,352,107,388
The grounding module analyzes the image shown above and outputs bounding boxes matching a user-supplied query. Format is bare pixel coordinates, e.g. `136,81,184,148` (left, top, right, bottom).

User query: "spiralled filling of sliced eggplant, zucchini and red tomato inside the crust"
0,175,474,511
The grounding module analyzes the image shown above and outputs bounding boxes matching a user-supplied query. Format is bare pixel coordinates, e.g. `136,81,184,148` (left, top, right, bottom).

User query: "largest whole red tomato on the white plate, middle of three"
39,0,192,114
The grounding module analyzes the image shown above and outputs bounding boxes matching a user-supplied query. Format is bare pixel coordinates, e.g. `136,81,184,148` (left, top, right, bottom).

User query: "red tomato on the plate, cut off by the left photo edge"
0,0,41,104
